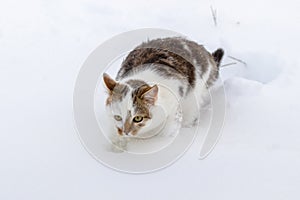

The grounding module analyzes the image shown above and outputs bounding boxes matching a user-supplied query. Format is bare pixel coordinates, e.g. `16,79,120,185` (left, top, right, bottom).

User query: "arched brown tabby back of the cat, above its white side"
117,37,218,88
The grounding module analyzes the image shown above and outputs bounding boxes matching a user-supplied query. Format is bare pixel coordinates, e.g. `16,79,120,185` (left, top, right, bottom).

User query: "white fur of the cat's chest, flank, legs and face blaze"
106,60,212,150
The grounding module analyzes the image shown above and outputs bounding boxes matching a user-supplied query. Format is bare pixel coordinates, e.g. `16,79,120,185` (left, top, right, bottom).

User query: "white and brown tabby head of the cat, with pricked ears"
103,73,158,136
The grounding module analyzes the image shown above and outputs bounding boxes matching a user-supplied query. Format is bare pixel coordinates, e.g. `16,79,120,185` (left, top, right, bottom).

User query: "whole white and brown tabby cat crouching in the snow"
103,37,224,147
